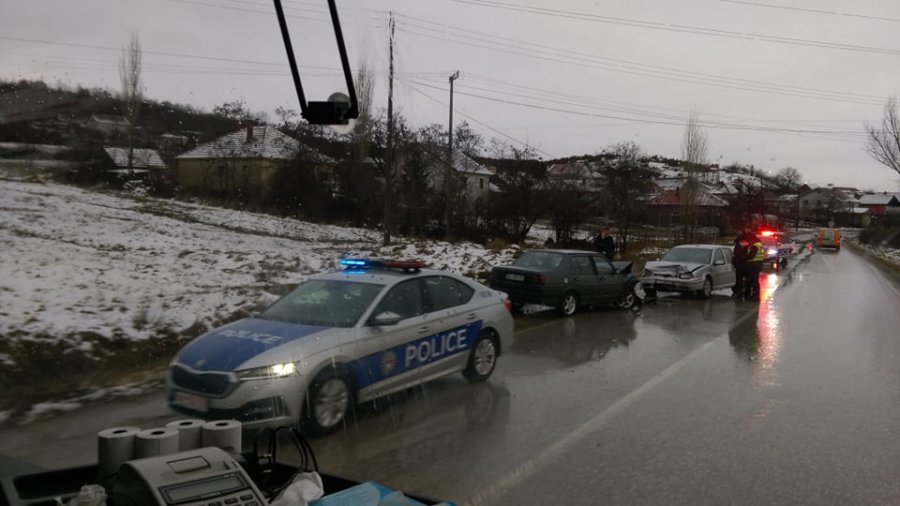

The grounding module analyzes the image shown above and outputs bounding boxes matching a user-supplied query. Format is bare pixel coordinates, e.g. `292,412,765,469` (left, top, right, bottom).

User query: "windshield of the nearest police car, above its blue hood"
259,279,384,327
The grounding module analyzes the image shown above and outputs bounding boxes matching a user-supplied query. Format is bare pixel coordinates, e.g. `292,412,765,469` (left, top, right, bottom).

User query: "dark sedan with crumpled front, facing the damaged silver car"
490,250,643,316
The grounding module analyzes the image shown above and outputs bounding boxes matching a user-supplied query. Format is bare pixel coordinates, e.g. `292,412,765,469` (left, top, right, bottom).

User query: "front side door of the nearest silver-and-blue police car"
351,278,431,401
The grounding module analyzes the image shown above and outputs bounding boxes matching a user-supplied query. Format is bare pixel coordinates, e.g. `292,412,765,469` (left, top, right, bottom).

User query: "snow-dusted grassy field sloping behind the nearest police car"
0,180,514,360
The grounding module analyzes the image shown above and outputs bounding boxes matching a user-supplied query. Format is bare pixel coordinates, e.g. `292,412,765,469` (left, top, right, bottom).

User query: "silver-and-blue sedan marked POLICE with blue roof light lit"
167,259,513,434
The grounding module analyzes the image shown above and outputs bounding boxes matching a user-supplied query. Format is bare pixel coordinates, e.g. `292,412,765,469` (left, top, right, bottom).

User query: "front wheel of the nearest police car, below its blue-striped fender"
304,369,353,435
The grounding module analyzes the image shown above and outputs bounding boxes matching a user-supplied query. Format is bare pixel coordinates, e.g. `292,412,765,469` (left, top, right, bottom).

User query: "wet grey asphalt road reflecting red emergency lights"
0,243,900,504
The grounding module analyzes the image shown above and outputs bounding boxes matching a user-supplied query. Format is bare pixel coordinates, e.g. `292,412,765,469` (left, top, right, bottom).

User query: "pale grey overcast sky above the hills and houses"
0,0,900,191
